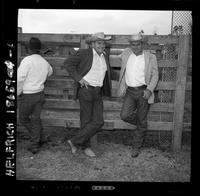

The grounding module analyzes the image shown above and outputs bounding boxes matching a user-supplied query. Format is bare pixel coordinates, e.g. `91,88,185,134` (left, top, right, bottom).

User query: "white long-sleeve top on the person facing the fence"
17,54,53,95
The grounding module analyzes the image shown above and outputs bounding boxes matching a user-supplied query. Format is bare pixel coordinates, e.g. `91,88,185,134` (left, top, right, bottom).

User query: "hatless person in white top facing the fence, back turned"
17,37,53,153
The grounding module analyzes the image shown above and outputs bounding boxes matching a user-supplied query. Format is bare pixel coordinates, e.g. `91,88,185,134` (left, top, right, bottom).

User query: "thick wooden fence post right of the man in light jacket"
172,35,189,151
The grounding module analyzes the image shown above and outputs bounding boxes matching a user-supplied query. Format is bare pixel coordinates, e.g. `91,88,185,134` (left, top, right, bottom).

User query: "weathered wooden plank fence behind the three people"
18,29,192,150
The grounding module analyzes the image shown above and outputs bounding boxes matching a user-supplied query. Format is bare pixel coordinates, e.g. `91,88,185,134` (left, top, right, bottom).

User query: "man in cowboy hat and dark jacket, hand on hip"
64,32,118,157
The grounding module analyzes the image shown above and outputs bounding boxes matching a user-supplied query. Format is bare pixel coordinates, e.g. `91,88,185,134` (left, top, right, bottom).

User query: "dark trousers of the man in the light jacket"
120,87,149,148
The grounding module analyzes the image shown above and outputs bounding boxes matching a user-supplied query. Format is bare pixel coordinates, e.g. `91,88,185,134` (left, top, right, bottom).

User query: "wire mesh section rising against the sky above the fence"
171,11,192,35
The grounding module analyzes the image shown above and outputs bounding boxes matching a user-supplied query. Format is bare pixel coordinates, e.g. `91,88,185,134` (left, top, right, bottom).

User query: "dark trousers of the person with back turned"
19,91,44,147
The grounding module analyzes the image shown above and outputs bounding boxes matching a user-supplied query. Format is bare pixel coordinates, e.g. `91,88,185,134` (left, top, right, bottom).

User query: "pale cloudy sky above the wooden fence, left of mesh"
18,9,172,35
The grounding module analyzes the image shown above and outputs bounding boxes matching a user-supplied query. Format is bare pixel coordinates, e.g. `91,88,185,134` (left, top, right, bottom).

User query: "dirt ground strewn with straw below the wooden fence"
16,129,191,182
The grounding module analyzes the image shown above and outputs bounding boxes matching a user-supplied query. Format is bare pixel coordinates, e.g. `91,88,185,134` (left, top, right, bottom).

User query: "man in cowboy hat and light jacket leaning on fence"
118,34,158,157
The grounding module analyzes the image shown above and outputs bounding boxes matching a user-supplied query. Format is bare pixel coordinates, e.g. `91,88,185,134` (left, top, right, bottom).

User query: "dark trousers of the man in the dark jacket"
71,86,104,149
